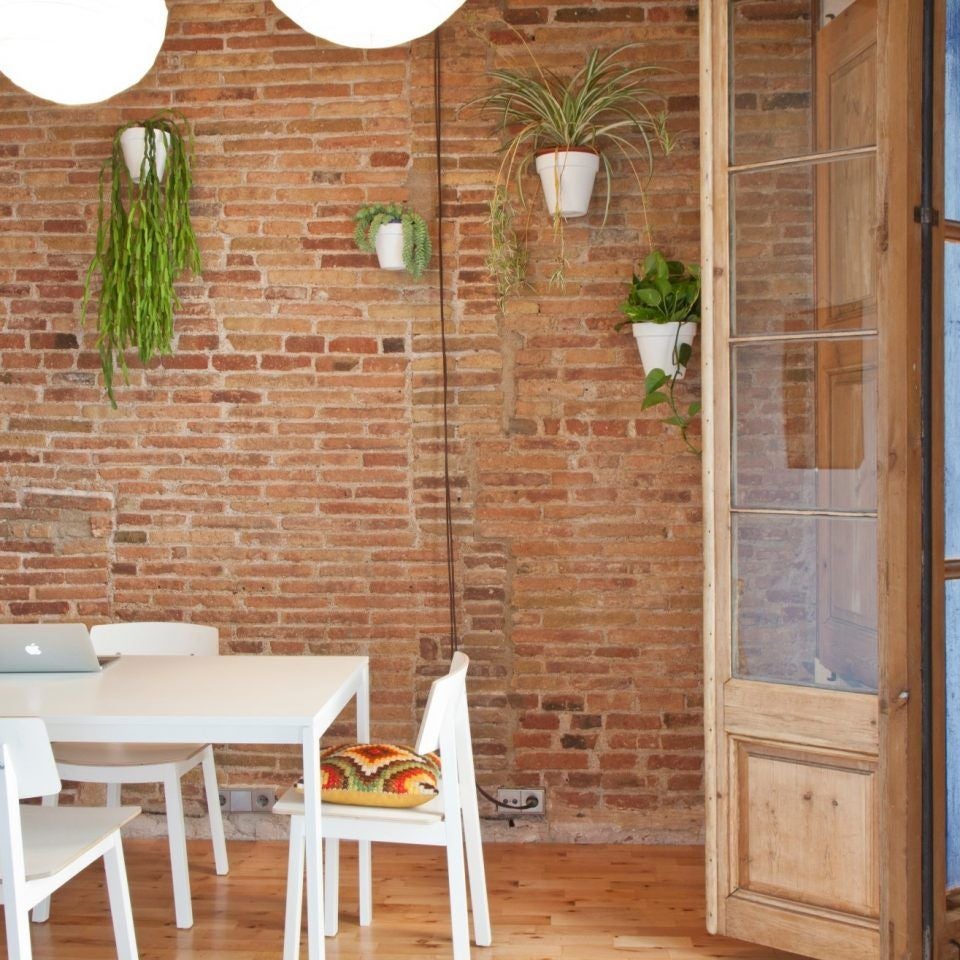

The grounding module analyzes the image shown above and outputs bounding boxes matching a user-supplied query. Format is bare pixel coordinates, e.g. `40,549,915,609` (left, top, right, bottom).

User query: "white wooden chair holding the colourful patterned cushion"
273,653,491,960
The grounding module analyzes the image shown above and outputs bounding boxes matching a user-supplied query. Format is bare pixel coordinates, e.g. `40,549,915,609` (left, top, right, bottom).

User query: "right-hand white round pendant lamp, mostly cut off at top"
274,0,464,50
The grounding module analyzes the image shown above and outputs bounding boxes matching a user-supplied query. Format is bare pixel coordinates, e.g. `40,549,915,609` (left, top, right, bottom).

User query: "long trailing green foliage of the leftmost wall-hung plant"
80,110,201,407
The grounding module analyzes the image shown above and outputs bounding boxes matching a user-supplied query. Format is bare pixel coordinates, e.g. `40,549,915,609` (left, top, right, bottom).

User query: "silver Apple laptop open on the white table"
0,623,116,673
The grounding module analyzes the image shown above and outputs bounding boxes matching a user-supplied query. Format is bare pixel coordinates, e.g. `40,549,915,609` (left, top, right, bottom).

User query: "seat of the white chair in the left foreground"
3,804,140,880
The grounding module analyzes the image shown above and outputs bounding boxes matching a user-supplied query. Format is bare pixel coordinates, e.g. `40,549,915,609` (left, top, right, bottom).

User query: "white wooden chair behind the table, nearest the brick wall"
34,623,230,928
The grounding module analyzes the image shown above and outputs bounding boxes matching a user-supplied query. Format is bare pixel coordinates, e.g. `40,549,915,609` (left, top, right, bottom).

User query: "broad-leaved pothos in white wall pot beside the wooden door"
616,250,701,454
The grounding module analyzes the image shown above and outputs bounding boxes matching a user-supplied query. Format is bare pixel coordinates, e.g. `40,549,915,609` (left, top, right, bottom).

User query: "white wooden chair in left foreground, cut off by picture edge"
0,717,140,960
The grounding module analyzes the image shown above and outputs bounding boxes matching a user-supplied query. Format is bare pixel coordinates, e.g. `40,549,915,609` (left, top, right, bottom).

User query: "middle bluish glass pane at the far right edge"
943,242,960,559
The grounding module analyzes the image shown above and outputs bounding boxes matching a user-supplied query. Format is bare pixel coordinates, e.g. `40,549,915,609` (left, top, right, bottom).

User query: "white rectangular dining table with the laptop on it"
0,656,370,960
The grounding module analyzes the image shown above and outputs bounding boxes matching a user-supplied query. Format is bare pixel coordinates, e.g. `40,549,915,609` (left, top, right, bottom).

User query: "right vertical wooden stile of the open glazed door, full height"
877,0,923,960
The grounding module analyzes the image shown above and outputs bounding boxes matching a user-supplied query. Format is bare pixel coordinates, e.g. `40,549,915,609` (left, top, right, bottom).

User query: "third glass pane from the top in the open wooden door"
732,338,877,512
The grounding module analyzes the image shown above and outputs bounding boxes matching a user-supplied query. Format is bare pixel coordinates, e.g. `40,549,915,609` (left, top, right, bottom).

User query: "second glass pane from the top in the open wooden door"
730,155,876,336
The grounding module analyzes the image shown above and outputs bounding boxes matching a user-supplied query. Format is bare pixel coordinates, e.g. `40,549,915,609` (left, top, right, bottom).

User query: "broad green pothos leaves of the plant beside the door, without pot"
616,250,702,456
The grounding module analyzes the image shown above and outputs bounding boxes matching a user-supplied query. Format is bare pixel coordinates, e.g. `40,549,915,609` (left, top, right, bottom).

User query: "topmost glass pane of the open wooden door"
730,0,877,165
